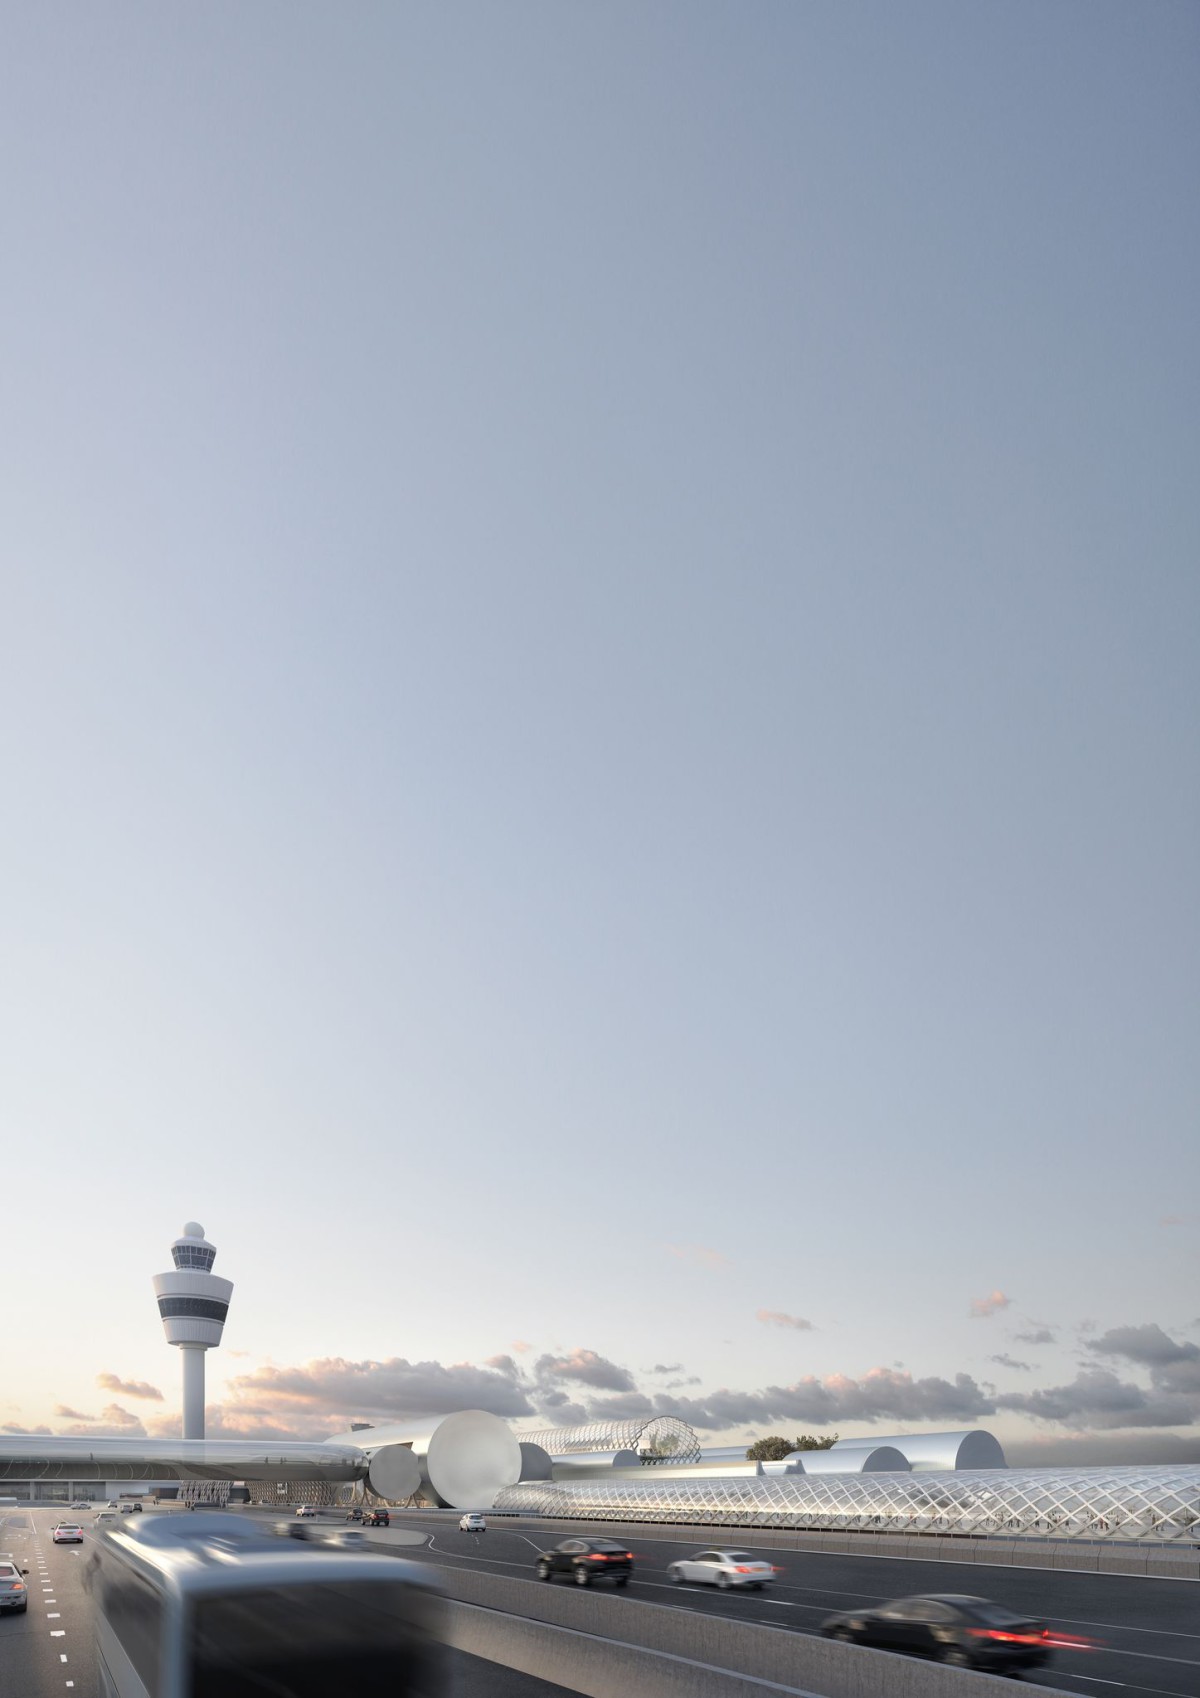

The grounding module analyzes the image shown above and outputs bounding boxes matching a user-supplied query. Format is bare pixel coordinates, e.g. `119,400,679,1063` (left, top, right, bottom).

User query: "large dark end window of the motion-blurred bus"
187,1581,441,1698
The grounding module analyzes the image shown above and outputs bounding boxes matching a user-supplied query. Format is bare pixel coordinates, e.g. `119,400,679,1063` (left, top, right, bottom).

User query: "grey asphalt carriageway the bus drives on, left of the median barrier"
0,1508,577,1698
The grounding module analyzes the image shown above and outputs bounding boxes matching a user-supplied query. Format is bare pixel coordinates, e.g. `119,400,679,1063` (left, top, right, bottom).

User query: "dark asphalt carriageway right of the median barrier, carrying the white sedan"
344,1511,1200,1698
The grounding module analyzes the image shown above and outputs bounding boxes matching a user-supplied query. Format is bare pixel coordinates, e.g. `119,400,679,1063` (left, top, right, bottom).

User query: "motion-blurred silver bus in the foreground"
85,1515,443,1698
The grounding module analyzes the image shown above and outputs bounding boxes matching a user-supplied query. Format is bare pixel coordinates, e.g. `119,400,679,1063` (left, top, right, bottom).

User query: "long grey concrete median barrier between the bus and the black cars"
431,1567,1072,1698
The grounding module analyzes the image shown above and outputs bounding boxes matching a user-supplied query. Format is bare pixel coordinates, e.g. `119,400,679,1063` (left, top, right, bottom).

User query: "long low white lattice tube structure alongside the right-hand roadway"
494,1465,1200,1543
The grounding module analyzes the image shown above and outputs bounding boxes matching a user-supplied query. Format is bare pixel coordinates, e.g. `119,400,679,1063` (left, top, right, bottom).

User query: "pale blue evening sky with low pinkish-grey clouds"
0,0,1200,1460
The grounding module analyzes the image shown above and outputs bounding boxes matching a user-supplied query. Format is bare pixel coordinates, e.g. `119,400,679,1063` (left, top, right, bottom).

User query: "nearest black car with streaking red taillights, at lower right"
820,1593,1051,1669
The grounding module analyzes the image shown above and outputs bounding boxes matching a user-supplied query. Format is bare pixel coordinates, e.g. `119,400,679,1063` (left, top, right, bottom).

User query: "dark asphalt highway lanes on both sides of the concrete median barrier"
0,1508,1200,1698
